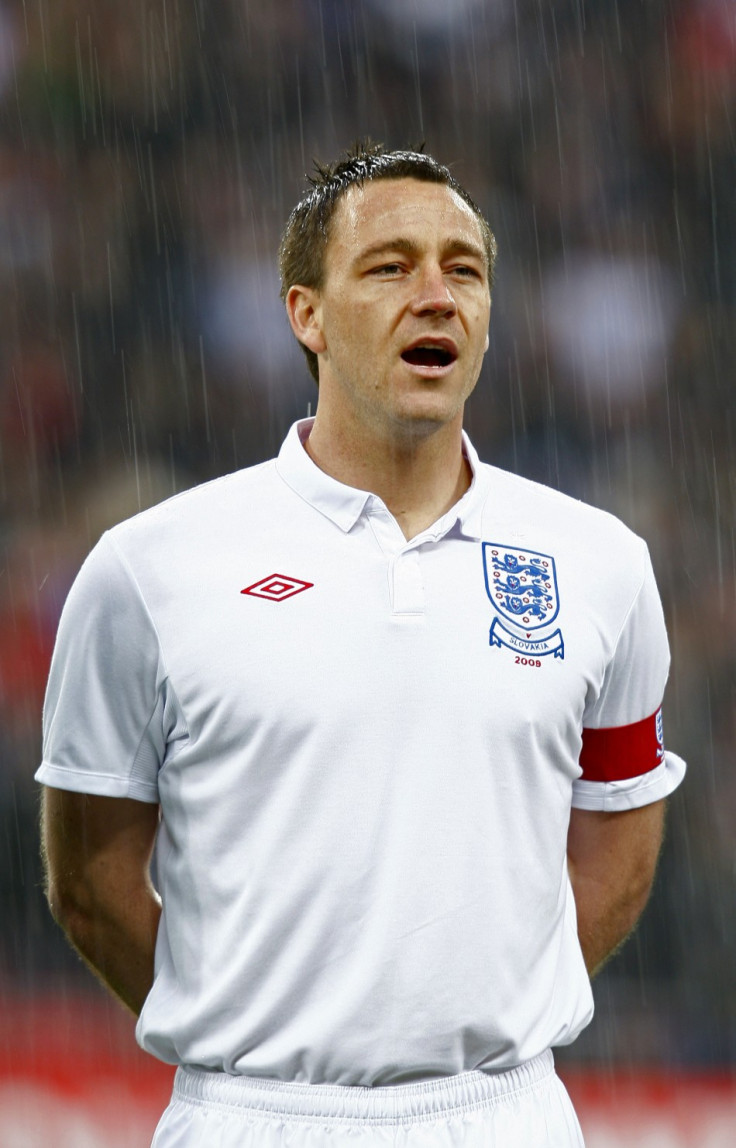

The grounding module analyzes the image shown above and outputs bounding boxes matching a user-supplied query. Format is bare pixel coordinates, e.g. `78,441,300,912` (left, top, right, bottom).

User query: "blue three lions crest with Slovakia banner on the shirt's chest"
483,542,565,658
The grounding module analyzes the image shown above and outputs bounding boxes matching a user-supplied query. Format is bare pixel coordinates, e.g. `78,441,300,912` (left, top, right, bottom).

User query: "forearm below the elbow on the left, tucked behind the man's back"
51,884,161,1016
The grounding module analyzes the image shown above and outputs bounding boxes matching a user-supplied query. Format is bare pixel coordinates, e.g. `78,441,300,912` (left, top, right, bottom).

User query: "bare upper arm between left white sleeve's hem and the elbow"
41,786,158,916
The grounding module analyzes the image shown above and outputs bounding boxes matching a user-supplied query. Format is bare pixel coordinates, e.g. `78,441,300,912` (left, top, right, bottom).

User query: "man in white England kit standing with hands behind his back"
38,146,684,1148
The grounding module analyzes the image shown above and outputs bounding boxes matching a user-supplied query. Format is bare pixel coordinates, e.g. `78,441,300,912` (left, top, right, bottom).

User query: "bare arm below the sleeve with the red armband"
567,801,665,976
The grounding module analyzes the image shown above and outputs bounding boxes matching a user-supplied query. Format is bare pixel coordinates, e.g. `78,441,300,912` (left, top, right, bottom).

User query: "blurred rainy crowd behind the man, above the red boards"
0,0,736,1068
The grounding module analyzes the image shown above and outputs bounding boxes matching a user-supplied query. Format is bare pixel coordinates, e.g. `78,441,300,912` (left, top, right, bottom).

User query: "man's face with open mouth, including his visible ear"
289,179,490,435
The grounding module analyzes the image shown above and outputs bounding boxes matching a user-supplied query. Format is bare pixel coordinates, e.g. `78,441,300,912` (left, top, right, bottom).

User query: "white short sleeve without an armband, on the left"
36,534,186,802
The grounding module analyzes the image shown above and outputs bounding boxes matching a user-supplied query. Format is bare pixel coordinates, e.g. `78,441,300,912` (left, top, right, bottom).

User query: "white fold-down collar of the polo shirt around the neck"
276,418,488,541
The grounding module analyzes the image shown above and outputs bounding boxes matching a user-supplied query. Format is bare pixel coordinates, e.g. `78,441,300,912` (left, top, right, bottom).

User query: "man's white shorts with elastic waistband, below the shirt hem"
152,1053,583,1148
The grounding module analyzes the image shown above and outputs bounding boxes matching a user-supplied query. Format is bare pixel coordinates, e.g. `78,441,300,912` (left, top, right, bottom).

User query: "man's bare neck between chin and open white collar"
305,410,472,540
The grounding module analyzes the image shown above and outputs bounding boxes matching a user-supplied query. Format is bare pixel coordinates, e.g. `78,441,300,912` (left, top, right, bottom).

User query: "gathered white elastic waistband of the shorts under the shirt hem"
173,1052,555,1124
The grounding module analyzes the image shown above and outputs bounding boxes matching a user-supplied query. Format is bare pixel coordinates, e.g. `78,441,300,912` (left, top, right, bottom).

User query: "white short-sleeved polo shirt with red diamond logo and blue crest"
37,420,684,1085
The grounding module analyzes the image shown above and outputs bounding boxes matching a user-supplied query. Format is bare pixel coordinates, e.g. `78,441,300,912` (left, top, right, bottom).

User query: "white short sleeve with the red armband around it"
573,543,685,812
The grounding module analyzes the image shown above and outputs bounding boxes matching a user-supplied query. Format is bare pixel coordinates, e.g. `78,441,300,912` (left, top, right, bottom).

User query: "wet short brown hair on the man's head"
279,140,496,382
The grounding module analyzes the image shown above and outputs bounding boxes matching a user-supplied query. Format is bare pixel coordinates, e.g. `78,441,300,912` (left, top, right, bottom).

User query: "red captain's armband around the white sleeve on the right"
580,707,665,782
